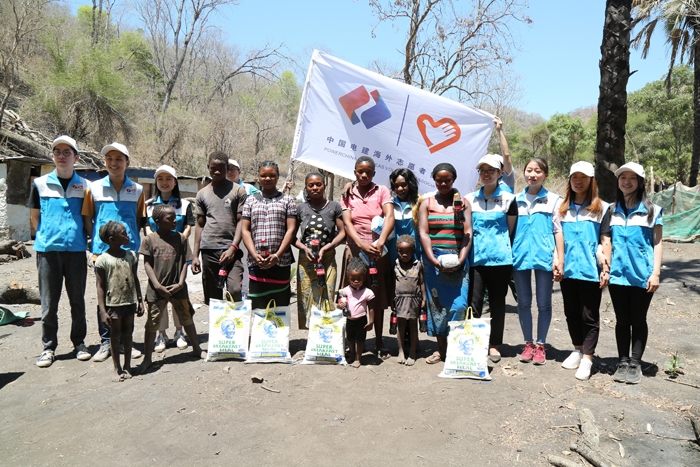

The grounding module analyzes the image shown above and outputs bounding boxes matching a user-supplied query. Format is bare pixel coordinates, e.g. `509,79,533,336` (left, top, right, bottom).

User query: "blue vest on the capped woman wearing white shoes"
561,201,610,282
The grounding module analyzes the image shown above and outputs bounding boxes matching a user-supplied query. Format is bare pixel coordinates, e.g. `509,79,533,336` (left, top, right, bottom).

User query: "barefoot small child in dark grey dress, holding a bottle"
391,235,427,366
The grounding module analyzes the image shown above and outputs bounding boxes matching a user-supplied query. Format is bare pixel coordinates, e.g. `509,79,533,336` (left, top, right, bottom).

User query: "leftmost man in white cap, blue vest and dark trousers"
27,136,91,368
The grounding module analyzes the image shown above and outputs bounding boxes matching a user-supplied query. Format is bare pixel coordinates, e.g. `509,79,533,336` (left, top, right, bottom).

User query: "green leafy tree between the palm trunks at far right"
627,65,694,183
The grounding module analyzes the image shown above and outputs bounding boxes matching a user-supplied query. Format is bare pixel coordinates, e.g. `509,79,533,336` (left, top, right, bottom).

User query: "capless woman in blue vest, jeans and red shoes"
513,157,564,365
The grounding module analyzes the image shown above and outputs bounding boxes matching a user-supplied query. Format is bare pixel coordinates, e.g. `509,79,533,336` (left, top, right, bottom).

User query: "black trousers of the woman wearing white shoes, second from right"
561,279,603,355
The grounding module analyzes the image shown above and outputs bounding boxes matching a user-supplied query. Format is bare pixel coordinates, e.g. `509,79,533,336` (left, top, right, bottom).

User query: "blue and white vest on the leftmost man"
34,170,88,252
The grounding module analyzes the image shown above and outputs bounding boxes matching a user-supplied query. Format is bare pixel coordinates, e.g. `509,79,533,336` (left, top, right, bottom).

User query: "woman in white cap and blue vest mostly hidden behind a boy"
146,165,194,352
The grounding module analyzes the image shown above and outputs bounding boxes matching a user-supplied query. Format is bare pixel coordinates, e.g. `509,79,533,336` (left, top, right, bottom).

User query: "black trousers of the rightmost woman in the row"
610,284,654,363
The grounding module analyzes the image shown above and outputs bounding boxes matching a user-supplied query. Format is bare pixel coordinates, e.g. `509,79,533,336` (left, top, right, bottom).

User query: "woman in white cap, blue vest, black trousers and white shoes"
556,161,610,380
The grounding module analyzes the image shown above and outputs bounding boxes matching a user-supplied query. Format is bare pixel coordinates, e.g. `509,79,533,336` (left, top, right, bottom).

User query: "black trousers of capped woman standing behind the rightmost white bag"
468,264,513,345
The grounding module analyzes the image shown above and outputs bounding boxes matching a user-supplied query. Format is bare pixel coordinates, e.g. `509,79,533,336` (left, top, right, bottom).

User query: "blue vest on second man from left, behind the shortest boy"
90,175,143,255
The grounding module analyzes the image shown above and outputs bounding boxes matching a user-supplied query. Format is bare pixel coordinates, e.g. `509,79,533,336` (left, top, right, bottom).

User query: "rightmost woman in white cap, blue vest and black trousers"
603,162,663,384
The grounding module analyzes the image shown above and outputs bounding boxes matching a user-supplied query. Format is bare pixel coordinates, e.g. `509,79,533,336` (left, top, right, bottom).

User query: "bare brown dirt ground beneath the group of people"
0,243,700,467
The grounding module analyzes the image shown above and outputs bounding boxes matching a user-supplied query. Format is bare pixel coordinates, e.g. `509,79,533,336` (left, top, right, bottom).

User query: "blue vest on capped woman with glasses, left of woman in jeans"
466,185,515,266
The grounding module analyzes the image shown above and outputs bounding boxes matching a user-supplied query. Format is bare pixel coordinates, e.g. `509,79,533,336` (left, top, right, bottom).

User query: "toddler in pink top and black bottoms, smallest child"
338,257,374,368
